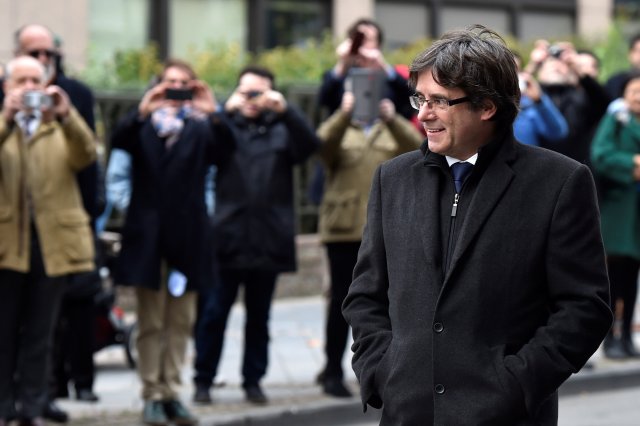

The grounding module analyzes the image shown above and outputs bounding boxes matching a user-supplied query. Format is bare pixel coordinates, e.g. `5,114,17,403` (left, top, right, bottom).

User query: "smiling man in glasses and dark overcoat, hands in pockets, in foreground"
343,26,612,426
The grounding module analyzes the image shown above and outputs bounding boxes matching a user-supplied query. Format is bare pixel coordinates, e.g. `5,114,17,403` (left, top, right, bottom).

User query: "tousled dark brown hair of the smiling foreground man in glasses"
409,25,520,125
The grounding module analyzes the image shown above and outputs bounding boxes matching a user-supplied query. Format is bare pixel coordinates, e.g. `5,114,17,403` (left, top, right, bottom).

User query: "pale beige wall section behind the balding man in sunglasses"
0,0,89,69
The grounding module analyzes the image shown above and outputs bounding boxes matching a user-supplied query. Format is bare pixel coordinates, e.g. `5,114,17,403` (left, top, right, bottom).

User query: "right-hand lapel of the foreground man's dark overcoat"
444,140,515,285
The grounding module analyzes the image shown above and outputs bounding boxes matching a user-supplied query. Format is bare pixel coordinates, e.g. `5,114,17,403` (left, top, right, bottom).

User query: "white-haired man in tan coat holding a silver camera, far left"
0,56,96,426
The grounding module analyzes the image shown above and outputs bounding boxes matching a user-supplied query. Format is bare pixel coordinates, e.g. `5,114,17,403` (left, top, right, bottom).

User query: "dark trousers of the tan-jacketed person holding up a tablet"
324,241,360,379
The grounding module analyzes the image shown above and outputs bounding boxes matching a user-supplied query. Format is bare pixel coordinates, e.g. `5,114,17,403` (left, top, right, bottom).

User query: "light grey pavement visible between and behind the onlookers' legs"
53,296,640,426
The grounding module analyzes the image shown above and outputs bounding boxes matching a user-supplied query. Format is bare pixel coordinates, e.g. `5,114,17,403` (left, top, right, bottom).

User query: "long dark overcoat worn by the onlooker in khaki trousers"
111,111,225,290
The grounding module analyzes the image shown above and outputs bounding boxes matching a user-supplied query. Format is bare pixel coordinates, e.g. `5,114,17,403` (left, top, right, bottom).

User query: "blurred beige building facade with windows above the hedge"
0,0,620,69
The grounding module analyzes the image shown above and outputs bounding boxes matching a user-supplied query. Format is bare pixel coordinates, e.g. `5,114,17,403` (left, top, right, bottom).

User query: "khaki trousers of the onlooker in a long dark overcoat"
136,280,197,401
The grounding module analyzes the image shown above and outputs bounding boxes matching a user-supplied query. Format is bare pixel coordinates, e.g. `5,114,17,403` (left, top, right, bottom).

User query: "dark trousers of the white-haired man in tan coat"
0,231,66,418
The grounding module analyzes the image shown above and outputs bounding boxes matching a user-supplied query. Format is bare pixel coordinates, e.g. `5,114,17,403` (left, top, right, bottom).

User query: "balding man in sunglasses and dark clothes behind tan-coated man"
9,24,103,422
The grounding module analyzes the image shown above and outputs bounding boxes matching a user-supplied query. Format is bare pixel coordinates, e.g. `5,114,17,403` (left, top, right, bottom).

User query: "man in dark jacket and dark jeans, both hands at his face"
194,67,319,403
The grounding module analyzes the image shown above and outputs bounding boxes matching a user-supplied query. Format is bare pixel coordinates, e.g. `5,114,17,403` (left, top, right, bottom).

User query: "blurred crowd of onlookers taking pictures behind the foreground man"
0,19,640,426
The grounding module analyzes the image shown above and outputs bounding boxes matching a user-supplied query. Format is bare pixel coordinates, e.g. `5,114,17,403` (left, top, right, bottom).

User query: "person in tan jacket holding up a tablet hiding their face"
318,92,422,397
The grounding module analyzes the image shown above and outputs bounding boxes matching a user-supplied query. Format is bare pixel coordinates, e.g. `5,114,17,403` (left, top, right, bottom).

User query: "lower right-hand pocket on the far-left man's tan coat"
56,209,95,262
